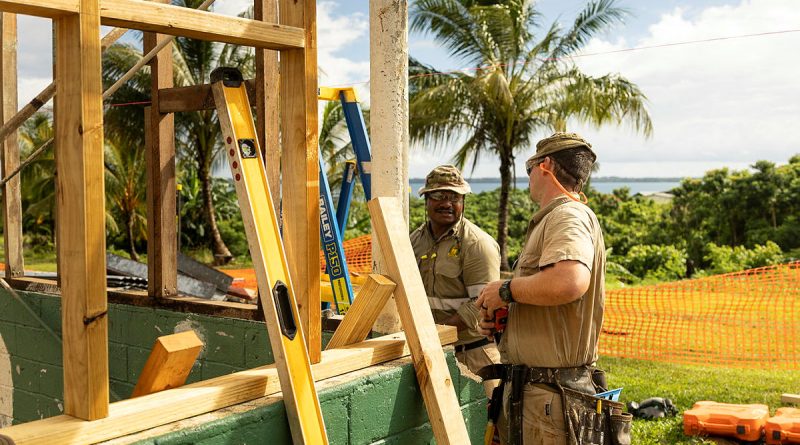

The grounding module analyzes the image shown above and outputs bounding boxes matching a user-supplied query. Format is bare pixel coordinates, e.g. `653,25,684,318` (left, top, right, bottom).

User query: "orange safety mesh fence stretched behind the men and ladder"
233,235,800,370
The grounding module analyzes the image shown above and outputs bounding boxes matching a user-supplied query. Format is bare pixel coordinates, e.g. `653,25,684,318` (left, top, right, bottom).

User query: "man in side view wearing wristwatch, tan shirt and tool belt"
476,133,629,445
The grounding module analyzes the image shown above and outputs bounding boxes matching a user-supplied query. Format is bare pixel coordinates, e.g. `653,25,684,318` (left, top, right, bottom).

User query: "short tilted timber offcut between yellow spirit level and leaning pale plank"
325,274,397,350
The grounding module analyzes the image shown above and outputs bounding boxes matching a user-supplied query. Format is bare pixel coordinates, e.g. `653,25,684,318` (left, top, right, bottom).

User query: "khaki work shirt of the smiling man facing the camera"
411,218,500,345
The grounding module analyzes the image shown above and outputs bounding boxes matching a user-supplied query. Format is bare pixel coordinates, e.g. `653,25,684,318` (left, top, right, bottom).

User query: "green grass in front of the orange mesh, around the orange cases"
598,357,800,445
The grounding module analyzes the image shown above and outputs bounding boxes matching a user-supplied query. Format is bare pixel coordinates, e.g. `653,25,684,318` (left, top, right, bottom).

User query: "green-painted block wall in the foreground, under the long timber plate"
125,353,486,445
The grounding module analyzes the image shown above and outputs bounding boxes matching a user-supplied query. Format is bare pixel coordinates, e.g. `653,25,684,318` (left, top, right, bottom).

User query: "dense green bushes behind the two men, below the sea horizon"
410,154,800,283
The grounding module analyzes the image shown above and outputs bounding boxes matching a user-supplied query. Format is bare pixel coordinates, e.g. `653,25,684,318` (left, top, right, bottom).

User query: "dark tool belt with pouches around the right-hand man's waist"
478,365,632,445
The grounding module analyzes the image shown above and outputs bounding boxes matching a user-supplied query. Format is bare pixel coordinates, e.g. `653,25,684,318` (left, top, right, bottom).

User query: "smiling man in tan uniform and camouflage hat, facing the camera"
411,165,500,396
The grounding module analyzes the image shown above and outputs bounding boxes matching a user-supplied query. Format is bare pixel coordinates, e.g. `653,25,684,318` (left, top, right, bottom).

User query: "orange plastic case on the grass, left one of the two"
683,401,769,441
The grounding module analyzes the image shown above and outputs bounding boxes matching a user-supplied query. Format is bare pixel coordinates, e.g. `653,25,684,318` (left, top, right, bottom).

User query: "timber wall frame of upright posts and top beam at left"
0,0,321,420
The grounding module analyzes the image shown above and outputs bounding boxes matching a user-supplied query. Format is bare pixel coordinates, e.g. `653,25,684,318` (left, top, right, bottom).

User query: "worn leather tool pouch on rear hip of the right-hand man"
562,387,633,445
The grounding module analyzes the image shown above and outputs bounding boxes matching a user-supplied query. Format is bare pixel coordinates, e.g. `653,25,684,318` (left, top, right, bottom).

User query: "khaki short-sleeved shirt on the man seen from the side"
499,195,606,368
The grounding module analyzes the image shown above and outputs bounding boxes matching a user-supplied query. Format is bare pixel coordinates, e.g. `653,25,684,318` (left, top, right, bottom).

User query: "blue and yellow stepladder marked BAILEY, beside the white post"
318,87,372,314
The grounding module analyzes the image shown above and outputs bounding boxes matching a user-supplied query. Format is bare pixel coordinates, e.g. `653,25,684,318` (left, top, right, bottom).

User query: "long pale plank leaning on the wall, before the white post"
369,197,476,445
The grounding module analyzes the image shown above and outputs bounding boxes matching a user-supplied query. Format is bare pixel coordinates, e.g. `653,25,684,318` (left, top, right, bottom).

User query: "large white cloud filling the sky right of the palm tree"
571,0,800,176
